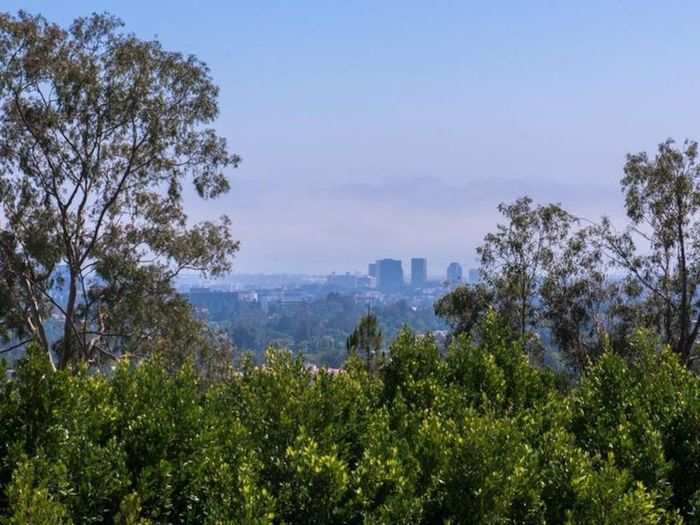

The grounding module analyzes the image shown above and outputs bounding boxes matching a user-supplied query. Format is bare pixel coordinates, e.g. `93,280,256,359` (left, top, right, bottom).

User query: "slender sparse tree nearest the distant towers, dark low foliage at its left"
434,197,578,364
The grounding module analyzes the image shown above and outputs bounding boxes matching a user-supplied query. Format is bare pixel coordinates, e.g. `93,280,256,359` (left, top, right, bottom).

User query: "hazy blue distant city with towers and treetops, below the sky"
177,257,479,367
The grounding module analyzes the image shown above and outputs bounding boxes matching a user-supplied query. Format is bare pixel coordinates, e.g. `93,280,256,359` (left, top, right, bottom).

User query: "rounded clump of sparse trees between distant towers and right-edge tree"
435,197,621,369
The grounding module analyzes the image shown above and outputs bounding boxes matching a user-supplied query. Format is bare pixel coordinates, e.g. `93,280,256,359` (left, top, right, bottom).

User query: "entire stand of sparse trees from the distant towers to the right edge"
435,139,700,374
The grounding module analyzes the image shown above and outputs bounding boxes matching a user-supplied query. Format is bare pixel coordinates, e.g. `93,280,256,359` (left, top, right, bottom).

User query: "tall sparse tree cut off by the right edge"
598,140,700,363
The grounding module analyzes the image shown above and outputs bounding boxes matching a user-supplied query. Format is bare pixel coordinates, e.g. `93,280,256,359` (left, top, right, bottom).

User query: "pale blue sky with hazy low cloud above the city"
5,0,700,275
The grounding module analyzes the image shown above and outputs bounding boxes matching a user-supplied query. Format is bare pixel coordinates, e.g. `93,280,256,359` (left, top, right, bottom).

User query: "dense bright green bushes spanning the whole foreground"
0,319,700,525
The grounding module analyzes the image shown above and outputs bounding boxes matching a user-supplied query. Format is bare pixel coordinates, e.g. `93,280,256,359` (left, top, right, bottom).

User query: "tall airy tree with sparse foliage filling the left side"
0,12,240,368
